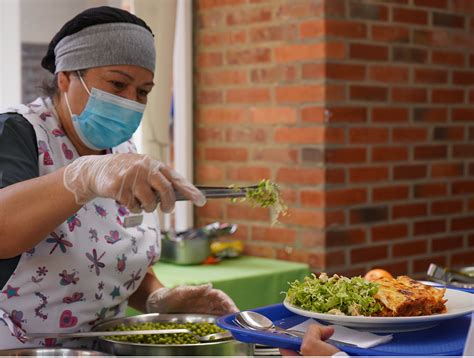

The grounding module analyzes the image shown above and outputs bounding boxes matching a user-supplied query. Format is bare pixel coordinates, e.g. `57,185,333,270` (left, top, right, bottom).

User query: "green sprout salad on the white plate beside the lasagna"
286,273,382,316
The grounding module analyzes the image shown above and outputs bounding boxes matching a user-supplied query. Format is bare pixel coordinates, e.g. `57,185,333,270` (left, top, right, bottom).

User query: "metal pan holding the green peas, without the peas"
93,313,253,356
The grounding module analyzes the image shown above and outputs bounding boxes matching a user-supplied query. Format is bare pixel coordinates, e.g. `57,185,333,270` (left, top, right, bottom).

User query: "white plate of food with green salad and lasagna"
283,273,474,332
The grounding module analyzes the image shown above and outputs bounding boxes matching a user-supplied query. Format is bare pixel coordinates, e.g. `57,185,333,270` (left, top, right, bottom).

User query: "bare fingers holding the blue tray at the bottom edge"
280,324,340,356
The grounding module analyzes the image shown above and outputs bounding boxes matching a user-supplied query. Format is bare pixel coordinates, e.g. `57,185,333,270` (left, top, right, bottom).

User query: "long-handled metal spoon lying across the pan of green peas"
27,328,232,342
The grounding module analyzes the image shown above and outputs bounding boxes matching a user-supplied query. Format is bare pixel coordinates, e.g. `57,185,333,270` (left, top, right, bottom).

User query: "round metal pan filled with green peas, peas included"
93,313,253,356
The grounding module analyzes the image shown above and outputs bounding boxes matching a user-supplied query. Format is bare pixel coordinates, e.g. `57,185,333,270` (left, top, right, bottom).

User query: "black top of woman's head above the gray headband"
41,6,153,73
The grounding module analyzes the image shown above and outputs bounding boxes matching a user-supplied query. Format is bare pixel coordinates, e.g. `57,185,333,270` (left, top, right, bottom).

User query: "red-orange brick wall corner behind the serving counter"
194,0,474,275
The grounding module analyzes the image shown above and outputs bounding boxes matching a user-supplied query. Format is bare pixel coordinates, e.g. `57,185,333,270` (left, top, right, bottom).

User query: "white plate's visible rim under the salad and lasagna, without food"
283,288,474,332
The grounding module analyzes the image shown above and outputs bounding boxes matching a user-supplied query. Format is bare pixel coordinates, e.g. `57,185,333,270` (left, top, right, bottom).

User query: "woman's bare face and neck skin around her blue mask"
56,65,154,155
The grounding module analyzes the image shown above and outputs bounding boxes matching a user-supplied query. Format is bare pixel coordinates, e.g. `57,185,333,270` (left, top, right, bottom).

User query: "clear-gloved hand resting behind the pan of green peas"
146,283,239,316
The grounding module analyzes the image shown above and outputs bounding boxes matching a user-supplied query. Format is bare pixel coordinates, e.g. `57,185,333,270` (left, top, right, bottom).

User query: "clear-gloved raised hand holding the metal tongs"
63,153,206,213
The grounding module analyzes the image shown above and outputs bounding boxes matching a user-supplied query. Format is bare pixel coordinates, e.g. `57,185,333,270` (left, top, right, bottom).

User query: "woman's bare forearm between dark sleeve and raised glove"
0,168,81,259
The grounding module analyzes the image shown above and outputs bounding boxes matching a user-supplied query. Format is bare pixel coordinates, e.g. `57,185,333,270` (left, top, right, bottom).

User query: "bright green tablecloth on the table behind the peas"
128,256,310,310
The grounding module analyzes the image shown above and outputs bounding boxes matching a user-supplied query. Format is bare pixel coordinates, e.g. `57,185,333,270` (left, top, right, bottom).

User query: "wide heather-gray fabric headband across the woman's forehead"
54,22,156,73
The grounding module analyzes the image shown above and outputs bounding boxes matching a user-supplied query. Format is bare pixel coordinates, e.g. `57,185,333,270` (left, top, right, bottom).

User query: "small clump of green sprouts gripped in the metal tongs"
230,179,288,224
